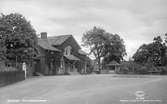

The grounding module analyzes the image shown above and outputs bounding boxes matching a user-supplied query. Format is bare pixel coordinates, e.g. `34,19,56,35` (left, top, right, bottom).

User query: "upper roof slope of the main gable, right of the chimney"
48,35,72,45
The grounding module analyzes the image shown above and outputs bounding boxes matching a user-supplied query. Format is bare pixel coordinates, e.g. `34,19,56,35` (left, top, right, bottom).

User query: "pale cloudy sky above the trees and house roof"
0,0,167,58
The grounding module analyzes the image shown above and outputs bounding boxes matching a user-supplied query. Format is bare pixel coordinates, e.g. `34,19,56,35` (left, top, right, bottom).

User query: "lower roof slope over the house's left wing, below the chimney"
38,39,60,52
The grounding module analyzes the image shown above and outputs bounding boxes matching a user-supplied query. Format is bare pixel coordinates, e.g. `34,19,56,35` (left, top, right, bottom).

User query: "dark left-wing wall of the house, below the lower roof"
35,47,62,75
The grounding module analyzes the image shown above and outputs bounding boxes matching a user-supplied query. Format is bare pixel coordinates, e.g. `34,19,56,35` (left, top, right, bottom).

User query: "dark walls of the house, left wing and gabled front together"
35,37,91,75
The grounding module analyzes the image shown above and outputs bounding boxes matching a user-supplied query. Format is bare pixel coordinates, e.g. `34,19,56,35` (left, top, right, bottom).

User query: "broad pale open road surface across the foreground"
0,75,167,104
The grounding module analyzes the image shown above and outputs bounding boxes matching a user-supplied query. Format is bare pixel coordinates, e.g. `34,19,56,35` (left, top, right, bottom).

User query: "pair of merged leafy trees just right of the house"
82,27,126,72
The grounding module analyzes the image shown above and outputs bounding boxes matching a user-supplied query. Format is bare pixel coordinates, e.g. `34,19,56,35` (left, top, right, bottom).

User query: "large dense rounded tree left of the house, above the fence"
0,13,37,66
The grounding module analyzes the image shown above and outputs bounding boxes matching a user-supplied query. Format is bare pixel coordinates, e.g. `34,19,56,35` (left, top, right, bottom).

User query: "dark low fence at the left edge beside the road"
0,71,25,87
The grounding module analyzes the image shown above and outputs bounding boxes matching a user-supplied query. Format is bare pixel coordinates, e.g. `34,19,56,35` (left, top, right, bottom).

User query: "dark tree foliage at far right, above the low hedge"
133,36,167,66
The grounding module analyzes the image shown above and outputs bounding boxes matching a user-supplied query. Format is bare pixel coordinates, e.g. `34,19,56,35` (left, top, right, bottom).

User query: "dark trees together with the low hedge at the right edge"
118,34,167,74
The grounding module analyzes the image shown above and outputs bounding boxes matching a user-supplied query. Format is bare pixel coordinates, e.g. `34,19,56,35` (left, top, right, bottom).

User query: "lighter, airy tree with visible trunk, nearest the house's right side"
82,27,106,72
